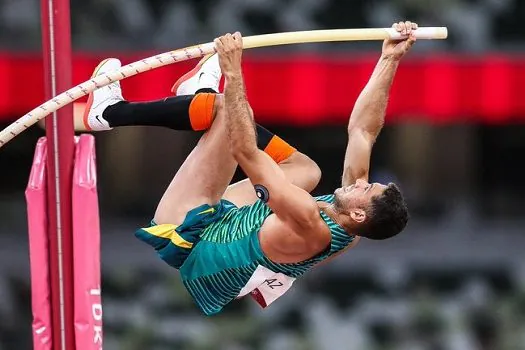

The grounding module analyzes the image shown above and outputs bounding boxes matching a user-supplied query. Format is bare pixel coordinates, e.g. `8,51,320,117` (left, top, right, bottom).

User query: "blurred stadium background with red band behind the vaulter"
0,0,525,350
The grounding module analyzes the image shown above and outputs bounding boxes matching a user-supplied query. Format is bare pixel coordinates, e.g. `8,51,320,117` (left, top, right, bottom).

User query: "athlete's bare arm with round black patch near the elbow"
215,33,322,235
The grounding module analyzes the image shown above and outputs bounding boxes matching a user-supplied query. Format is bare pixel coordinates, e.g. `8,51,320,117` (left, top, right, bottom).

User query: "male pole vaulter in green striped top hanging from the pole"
83,21,417,315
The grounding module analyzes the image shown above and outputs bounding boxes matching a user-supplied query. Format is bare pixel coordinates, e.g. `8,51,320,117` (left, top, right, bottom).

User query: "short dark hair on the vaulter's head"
357,183,408,240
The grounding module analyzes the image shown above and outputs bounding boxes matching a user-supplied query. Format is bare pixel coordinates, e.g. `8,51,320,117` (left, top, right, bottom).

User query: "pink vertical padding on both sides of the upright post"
26,135,103,350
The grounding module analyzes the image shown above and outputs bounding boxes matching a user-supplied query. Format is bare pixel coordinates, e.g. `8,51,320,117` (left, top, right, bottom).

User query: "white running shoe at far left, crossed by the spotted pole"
83,58,124,131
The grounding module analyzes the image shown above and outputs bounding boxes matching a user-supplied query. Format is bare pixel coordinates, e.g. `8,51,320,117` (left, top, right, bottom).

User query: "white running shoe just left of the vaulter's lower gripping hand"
171,54,222,96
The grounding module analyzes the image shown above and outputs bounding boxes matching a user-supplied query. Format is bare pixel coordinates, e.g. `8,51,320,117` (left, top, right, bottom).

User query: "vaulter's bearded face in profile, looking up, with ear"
334,180,387,223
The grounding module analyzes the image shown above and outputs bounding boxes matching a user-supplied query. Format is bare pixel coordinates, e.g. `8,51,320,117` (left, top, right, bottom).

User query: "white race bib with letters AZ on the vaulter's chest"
237,265,295,308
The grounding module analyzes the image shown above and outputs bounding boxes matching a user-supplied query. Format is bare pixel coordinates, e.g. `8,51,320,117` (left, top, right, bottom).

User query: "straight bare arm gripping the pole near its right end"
343,22,417,186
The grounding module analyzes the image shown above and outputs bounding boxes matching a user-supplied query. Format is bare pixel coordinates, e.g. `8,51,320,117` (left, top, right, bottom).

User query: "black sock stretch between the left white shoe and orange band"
103,95,194,130
